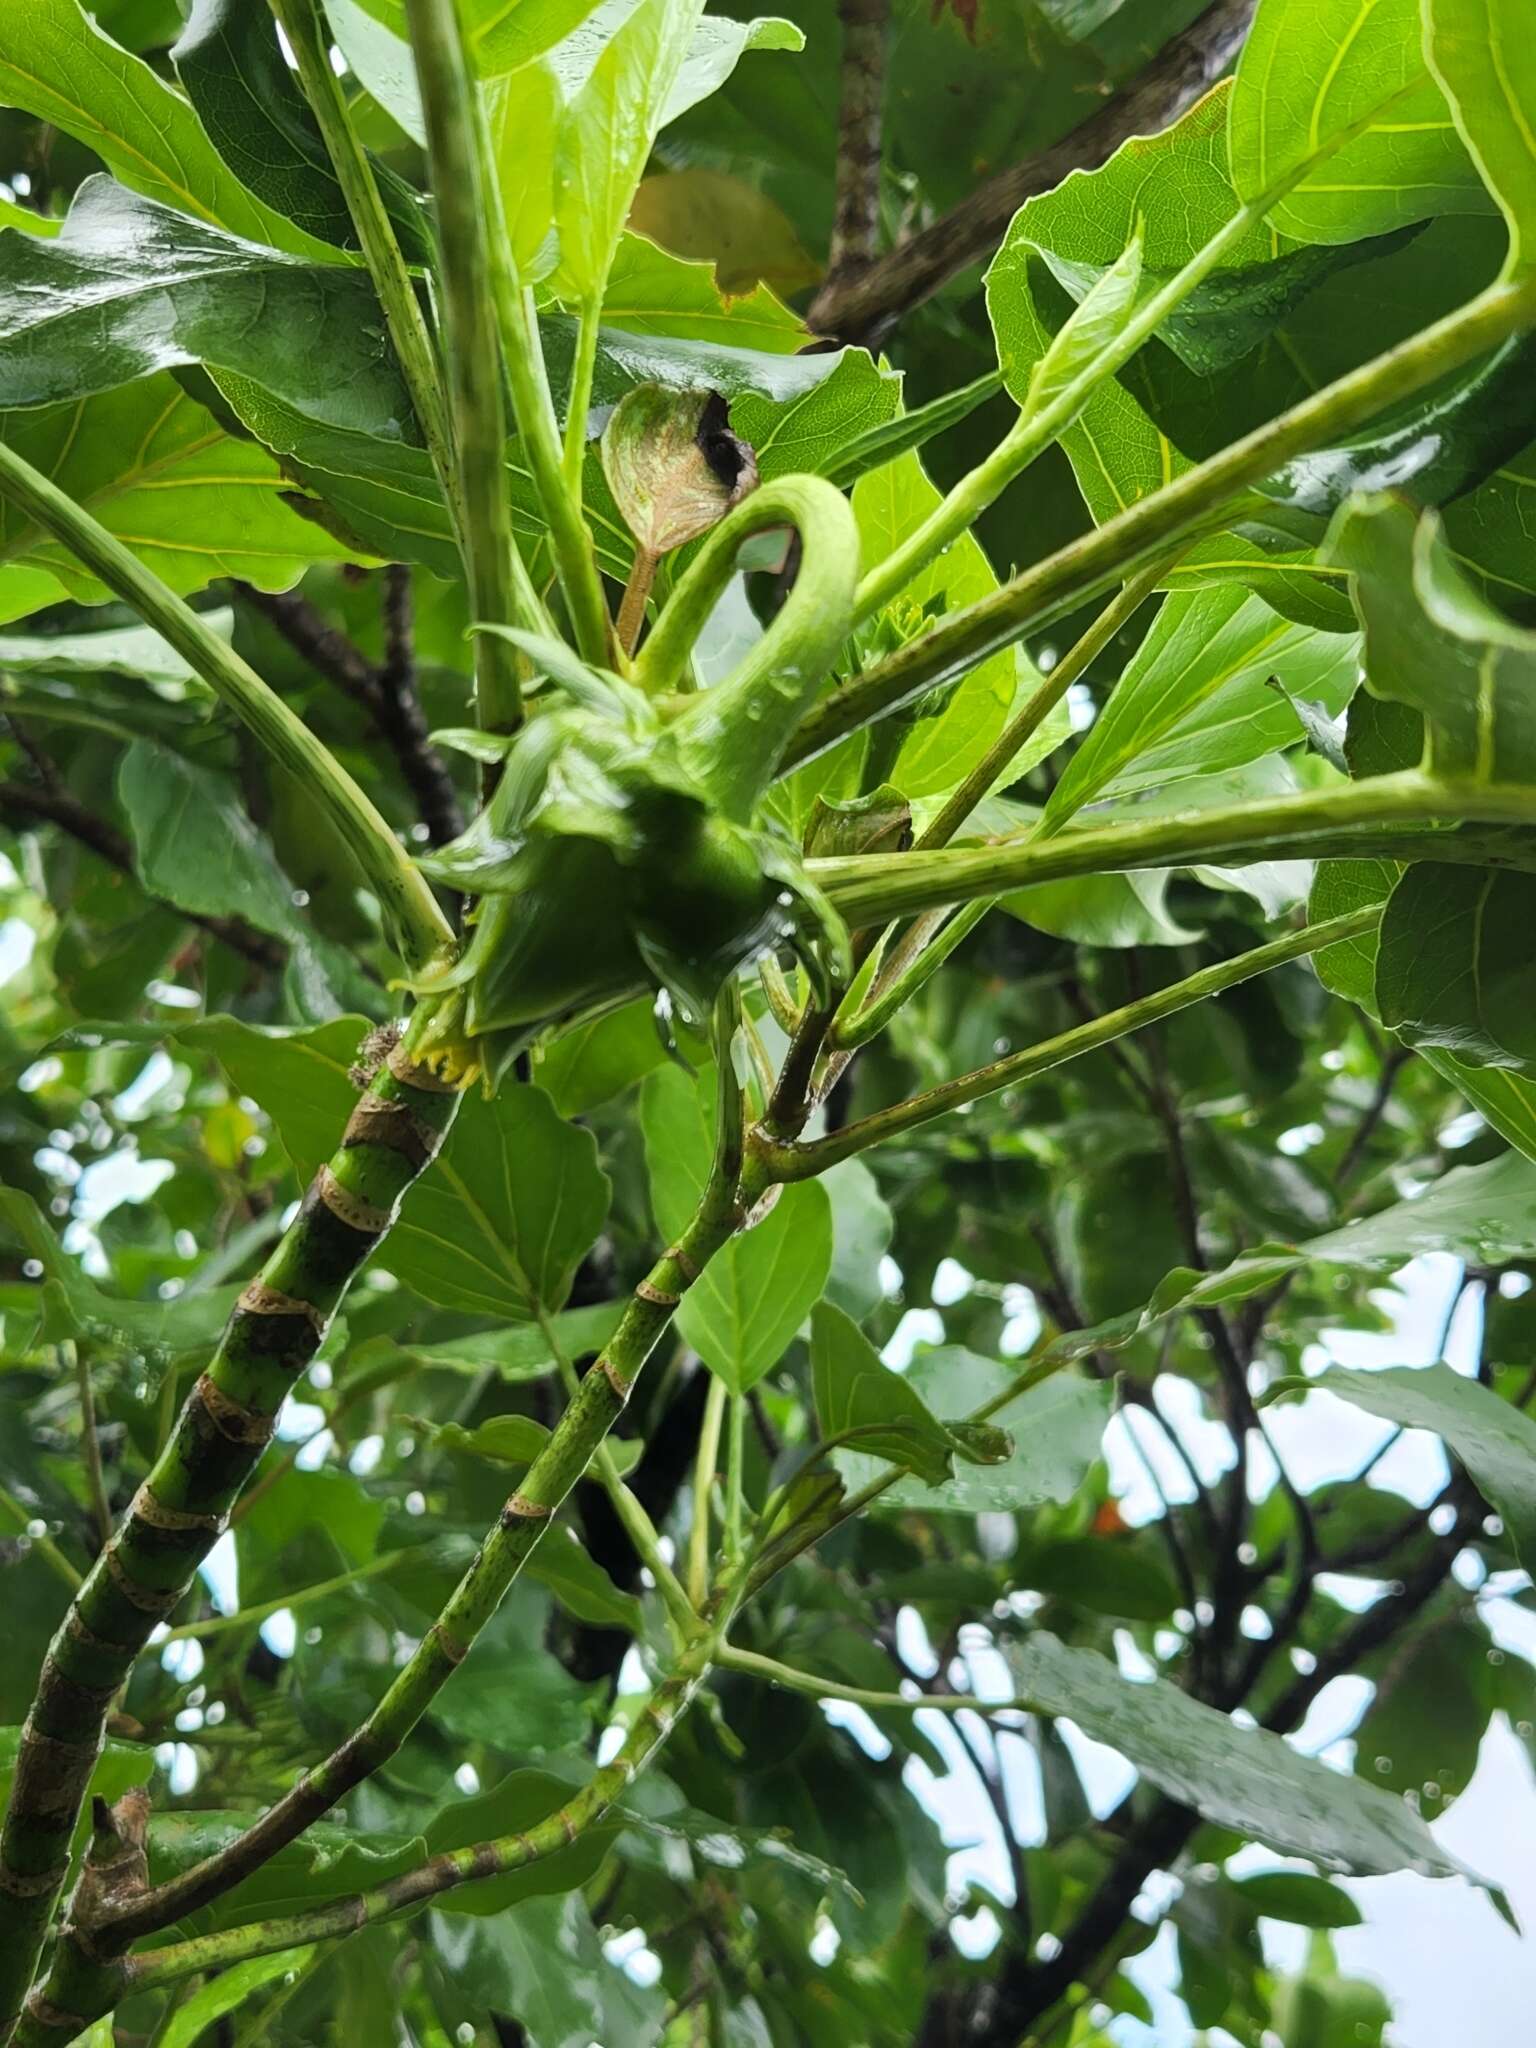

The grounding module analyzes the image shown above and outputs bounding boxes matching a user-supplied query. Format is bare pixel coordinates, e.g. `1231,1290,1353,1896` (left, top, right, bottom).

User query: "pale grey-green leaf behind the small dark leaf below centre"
834,1346,1110,1513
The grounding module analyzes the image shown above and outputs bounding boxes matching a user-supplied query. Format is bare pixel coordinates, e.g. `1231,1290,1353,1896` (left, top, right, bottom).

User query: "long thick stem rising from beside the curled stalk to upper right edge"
784,276,1536,768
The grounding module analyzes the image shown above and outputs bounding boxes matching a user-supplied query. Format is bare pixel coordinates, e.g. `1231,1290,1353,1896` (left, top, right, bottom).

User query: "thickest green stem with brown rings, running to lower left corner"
0,1010,467,2040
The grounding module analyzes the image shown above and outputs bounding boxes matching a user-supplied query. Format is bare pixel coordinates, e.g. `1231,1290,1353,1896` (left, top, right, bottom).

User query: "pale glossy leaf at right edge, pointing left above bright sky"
1274,1368,1536,1571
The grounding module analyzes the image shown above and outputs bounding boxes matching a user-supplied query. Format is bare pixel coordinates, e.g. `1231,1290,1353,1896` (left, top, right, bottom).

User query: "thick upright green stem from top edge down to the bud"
406,0,545,733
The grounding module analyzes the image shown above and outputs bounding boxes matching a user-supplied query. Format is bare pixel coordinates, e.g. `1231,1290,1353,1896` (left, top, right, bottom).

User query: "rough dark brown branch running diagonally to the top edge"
807,0,1255,342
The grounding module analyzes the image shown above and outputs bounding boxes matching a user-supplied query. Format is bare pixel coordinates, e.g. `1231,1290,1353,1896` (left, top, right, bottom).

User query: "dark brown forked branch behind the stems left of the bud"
236,565,463,846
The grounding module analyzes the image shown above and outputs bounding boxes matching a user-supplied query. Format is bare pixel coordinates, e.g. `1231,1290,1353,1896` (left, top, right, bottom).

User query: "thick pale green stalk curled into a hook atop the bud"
635,477,858,821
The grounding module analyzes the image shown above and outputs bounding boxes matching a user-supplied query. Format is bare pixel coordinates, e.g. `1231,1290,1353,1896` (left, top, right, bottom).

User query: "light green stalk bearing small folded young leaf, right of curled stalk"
856,208,1261,621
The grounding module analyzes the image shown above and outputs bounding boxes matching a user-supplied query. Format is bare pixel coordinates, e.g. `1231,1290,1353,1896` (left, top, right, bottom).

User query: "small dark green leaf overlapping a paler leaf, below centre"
811,1303,1014,1487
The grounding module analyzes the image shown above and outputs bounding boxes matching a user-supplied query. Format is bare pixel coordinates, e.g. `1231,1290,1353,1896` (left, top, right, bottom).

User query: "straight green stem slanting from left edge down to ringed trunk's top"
0,446,455,971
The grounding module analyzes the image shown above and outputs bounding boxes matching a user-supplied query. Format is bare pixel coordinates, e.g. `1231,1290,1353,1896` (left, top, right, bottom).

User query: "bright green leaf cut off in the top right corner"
1425,0,1536,274
